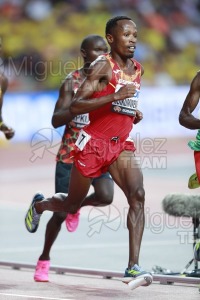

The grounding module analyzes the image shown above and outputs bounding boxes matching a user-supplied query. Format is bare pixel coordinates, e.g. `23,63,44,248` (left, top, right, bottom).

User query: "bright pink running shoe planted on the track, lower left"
34,260,50,282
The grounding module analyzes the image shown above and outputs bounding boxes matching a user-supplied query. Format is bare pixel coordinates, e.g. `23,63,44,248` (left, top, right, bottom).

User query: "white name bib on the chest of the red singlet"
111,84,139,117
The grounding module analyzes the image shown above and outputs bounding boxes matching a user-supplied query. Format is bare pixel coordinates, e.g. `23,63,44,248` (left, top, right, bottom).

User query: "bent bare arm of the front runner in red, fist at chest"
70,59,135,114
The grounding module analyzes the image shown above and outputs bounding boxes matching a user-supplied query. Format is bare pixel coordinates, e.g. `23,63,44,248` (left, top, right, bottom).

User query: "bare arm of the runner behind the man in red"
52,76,74,128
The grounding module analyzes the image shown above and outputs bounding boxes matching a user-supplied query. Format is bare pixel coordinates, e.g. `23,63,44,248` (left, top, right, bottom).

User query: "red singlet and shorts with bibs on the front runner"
72,54,142,177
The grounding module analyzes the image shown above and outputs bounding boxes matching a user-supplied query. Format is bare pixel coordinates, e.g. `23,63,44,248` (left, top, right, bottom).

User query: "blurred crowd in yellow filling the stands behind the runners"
0,0,200,91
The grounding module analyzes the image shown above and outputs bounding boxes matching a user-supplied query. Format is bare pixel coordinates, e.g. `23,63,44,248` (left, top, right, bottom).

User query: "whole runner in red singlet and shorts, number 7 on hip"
25,16,152,286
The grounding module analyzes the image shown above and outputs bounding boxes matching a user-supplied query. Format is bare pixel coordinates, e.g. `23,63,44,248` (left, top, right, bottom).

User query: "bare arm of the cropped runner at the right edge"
179,72,200,129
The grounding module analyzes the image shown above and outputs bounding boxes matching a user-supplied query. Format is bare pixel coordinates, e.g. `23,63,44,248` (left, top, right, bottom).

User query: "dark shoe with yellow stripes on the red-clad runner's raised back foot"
25,193,44,233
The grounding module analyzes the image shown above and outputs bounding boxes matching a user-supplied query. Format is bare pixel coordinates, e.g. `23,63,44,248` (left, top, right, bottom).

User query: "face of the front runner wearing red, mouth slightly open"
106,20,137,58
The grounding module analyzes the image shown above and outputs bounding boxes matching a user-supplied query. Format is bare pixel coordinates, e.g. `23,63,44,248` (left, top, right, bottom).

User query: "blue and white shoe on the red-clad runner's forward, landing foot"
122,264,153,286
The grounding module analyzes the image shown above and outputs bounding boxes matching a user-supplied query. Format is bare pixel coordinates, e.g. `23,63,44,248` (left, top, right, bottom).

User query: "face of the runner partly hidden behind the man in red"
85,38,108,63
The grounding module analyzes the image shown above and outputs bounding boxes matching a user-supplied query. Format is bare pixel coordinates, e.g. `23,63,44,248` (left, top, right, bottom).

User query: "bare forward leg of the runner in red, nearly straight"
109,151,145,269
